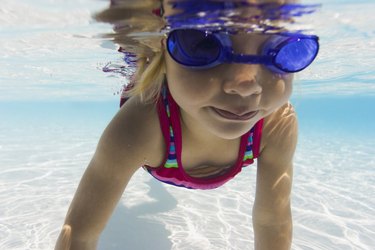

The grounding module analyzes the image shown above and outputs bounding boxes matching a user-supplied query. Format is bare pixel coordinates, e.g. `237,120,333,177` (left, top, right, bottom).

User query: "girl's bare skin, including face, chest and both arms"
55,0,297,250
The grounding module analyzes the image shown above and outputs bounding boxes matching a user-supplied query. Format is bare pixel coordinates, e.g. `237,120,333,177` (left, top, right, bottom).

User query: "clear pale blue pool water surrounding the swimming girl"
0,0,375,250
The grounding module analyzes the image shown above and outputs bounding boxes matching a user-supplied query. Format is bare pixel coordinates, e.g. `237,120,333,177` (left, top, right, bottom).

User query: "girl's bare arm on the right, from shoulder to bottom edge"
253,104,298,250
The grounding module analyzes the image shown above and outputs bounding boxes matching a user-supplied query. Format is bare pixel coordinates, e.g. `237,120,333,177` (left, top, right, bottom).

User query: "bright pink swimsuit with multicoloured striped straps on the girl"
143,87,263,189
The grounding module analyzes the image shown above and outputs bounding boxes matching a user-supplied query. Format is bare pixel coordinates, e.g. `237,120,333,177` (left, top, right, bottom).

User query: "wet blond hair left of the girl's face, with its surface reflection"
94,0,165,102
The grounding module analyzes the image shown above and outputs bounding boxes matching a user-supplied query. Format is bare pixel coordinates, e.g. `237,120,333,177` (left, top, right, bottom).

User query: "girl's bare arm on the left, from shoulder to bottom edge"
55,97,164,250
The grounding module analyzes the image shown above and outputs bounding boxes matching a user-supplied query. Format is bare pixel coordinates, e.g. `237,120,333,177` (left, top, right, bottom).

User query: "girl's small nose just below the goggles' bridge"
223,64,262,97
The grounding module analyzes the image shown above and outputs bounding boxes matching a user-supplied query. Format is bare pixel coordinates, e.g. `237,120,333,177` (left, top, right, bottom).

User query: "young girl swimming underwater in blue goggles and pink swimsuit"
56,1,318,250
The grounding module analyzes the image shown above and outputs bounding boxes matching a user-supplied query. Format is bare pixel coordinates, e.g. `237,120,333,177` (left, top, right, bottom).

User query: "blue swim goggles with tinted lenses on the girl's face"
167,29,319,74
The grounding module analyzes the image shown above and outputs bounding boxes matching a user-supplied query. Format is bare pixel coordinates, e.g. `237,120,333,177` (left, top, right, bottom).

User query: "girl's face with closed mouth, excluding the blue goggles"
165,31,293,139
